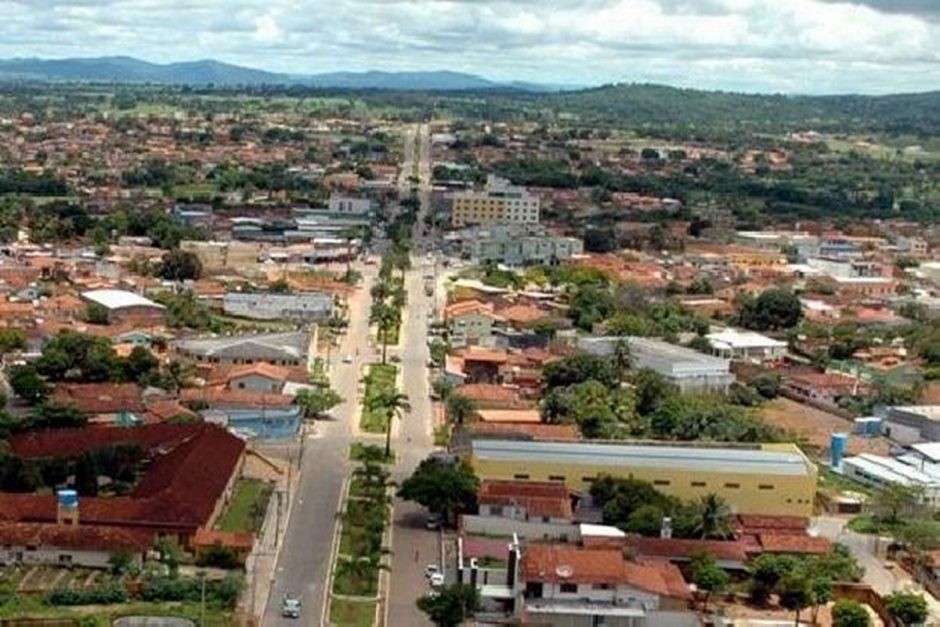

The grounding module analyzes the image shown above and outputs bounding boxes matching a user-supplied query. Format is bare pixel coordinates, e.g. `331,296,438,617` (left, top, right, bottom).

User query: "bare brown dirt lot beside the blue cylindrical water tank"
760,398,889,455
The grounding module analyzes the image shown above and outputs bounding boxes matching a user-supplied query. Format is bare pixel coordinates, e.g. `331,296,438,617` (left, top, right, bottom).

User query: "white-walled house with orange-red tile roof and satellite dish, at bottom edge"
510,543,698,627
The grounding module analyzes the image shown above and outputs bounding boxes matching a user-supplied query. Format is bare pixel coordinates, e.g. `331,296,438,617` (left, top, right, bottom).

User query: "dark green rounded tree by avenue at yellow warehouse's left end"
398,457,479,523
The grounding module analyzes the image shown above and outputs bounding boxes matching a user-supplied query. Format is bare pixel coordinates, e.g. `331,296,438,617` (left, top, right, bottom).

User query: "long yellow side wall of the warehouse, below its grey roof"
470,456,816,516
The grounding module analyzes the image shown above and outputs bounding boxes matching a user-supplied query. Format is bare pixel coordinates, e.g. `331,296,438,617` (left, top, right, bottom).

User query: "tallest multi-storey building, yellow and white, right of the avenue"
451,175,539,228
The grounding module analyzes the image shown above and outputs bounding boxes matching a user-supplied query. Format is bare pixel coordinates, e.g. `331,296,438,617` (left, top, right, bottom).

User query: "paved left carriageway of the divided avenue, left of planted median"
259,266,375,627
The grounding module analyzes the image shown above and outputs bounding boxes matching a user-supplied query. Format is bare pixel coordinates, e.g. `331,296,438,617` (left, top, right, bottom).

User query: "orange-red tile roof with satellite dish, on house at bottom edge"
522,544,691,599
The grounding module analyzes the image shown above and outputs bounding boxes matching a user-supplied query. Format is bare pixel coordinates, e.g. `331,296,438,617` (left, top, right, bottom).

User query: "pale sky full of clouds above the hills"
0,0,940,93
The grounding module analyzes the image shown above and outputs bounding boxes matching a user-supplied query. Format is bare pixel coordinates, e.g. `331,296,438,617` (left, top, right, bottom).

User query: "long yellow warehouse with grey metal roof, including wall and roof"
470,439,816,517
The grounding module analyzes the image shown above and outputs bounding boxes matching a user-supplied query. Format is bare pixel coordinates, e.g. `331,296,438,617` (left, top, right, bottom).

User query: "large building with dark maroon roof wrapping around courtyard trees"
0,423,246,548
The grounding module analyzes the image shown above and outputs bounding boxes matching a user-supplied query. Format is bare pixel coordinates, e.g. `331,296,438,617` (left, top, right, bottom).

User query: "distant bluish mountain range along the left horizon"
0,57,563,92
